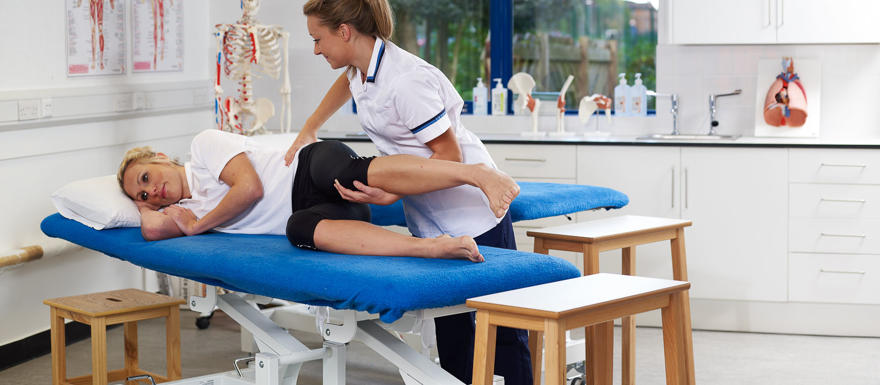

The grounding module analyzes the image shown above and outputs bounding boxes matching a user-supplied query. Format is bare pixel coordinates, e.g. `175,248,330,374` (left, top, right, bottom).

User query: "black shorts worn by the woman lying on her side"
287,140,374,249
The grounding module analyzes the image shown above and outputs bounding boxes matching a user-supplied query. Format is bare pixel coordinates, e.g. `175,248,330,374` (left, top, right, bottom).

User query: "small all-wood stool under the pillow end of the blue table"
43,289,186,385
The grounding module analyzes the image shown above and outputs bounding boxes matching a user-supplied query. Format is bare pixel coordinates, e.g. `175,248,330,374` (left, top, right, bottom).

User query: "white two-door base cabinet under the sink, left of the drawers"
578,146,788,301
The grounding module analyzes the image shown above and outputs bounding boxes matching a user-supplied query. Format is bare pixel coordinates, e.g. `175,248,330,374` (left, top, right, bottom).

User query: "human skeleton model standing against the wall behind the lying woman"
214,0,290,135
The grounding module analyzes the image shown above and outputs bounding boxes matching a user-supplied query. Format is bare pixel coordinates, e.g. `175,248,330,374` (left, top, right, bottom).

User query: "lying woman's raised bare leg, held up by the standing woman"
367,155,519,218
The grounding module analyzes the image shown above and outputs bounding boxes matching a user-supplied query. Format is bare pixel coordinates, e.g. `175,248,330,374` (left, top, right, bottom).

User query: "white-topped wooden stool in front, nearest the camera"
467,274,693,385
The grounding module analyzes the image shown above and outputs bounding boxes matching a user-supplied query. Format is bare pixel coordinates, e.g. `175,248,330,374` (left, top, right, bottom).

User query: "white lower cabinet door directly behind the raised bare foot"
577,146,690,279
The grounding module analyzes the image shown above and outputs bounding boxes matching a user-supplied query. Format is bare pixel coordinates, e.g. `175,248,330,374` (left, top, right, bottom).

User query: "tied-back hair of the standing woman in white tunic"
303,0,394,40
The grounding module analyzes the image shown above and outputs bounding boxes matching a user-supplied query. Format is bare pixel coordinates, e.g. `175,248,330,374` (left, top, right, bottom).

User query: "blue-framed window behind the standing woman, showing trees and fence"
390,0,658,109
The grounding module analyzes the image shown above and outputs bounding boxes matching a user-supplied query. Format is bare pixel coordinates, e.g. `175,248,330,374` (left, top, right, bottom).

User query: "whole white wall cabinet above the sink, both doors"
668,0,880,44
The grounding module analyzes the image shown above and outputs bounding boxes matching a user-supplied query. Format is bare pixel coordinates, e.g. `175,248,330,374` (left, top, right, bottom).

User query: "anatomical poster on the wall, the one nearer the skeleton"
131,0,184,72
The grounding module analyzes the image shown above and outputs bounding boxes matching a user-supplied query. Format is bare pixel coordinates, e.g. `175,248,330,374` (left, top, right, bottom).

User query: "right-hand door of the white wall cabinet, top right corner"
776,0,880,44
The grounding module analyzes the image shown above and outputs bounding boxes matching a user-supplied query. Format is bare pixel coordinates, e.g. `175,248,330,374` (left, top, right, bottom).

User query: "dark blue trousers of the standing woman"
434,213,532,385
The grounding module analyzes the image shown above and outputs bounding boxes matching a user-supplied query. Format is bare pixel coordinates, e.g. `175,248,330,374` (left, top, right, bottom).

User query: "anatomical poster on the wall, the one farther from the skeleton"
66,0,125,76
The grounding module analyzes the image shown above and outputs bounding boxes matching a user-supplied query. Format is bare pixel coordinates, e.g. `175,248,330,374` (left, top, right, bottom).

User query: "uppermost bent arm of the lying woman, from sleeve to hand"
165,153,263,235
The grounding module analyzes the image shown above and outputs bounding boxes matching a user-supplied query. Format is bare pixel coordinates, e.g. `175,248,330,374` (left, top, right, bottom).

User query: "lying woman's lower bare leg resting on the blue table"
314,219,483,262
